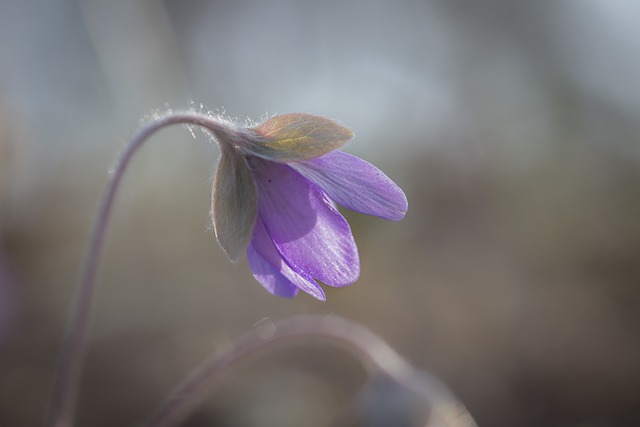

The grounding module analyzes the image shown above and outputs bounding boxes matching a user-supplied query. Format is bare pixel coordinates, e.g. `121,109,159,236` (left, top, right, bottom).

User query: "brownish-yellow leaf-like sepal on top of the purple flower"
243,113,353,162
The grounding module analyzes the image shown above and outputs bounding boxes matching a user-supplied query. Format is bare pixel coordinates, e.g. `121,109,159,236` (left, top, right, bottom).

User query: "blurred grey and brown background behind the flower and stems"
0,0,640,427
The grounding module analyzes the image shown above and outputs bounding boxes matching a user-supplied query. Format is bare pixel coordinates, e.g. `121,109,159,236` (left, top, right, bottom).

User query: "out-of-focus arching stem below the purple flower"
142,315,476,427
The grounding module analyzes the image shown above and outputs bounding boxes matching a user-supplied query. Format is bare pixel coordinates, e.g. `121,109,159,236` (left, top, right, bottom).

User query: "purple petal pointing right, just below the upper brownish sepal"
291,151,408,221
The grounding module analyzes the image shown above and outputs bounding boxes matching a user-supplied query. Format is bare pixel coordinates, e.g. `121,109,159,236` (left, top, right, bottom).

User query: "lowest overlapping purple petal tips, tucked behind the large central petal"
247,219,326,301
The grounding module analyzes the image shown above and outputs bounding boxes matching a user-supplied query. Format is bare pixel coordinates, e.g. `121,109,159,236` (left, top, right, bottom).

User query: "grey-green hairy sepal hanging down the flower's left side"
211,145,258,261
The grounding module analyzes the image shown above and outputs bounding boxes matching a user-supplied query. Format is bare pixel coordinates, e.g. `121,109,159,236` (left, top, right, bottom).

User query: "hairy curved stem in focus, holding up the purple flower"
45,112,235,427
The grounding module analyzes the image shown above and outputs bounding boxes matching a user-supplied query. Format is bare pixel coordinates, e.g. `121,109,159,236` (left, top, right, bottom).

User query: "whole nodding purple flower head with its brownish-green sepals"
212,114,407,301
